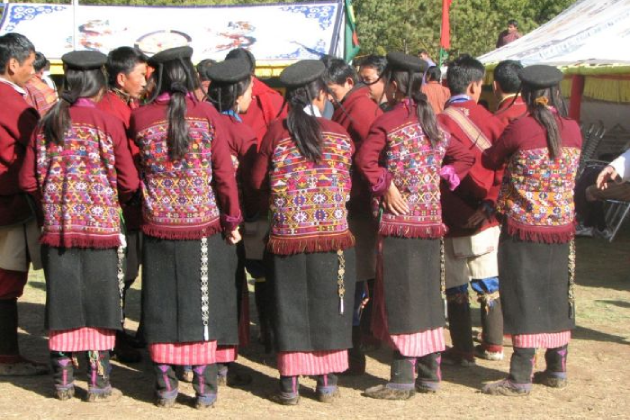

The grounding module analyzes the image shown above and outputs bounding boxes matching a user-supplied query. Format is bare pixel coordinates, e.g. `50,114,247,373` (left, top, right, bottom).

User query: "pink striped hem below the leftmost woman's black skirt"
48,327,116,352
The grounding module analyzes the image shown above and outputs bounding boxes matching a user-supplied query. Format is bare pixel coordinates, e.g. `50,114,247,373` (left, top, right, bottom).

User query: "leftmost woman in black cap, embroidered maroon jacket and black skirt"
20,51,139,401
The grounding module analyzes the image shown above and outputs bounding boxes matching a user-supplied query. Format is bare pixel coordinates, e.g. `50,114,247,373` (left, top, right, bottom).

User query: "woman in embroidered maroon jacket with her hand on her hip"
355,53,473,399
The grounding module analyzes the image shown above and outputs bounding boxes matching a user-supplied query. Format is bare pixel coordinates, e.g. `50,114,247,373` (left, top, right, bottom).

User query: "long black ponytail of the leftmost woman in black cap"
40,68,107,145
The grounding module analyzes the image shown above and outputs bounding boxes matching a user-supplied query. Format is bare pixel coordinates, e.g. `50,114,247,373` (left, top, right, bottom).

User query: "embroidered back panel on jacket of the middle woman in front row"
270,132,352,239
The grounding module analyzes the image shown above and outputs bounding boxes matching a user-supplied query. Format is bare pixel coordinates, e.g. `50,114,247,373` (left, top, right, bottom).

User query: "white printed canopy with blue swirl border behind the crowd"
0,0,344,62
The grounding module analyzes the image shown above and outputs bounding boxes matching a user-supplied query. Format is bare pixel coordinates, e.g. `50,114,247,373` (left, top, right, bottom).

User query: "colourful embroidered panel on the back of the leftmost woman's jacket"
37,124,120,246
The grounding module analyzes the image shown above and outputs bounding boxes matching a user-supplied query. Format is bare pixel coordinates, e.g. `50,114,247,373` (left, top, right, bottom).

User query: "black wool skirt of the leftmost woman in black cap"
41,245,122,331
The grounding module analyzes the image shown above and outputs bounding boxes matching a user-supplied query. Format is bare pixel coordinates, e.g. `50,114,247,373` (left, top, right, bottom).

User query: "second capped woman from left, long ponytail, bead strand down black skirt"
130,47,241,408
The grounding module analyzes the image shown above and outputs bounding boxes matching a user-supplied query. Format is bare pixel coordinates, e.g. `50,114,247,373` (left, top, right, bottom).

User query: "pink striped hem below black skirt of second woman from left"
149,340,217,366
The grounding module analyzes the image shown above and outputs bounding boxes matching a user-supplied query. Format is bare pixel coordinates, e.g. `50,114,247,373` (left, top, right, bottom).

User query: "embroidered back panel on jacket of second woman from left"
136,118,219,228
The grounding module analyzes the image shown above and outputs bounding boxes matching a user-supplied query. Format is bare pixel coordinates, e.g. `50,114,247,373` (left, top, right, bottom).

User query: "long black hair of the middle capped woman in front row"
285,78,325,162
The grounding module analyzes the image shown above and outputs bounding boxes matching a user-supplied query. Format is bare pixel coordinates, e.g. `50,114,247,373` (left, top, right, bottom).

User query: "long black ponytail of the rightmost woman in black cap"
522,84,567,160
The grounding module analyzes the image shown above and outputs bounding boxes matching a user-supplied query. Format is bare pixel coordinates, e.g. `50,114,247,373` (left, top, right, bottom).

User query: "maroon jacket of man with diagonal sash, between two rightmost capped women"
437,100,505,237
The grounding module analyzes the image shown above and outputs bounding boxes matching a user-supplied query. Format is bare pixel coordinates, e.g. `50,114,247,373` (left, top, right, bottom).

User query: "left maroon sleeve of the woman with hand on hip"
355,118,392,196
